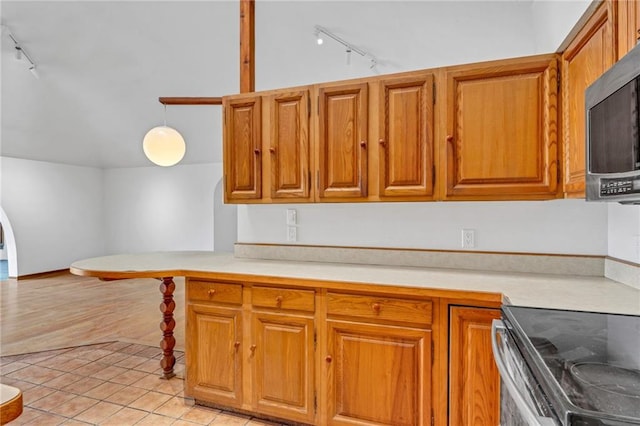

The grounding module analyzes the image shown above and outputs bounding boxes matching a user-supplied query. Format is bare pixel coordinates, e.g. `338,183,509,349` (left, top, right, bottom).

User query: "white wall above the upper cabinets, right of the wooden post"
256,1,536,90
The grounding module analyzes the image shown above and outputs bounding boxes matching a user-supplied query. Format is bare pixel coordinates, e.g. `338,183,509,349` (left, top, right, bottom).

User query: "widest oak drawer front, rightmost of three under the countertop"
327,293,433,324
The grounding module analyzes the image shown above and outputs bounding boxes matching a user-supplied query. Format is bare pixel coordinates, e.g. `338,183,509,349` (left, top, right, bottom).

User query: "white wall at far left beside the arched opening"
0,157,104,276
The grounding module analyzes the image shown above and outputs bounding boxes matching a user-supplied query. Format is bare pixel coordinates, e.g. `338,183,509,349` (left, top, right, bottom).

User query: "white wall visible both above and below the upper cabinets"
232,1,607,255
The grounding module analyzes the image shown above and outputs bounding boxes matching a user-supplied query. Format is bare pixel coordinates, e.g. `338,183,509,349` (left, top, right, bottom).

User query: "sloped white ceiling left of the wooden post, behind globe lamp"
1,1,239,168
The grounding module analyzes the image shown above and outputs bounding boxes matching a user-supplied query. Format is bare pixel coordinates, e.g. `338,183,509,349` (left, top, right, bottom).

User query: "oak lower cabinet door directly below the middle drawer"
253,312,315,423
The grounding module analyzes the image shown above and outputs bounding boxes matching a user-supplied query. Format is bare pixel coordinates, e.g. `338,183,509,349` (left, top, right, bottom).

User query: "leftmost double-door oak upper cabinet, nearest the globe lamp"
223,89,312,203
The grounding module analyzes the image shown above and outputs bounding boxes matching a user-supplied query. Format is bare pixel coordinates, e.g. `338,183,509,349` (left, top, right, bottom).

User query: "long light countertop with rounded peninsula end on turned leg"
71,251,640,315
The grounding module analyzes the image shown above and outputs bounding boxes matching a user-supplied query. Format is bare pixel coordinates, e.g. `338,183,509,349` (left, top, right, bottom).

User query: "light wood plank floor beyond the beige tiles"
0,273,184,355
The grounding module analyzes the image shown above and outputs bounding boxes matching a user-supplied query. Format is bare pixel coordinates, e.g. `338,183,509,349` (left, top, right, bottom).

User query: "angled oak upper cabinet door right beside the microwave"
562,2,614,197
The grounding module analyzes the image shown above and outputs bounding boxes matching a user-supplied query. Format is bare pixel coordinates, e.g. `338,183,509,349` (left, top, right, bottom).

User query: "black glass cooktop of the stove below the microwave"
502,306,640,425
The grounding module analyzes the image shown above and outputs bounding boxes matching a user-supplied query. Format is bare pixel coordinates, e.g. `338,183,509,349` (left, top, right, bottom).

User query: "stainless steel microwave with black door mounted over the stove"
585,44,640,204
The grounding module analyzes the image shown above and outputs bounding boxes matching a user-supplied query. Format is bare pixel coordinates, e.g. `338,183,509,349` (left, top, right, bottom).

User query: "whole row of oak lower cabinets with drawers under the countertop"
185,277,500,426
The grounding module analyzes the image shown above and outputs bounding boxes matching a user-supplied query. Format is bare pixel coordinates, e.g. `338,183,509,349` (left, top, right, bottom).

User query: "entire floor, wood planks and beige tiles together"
0,273,278,426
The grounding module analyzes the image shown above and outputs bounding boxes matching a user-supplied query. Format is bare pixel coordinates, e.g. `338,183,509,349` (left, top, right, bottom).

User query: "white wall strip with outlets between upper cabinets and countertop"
238,200,607,255
